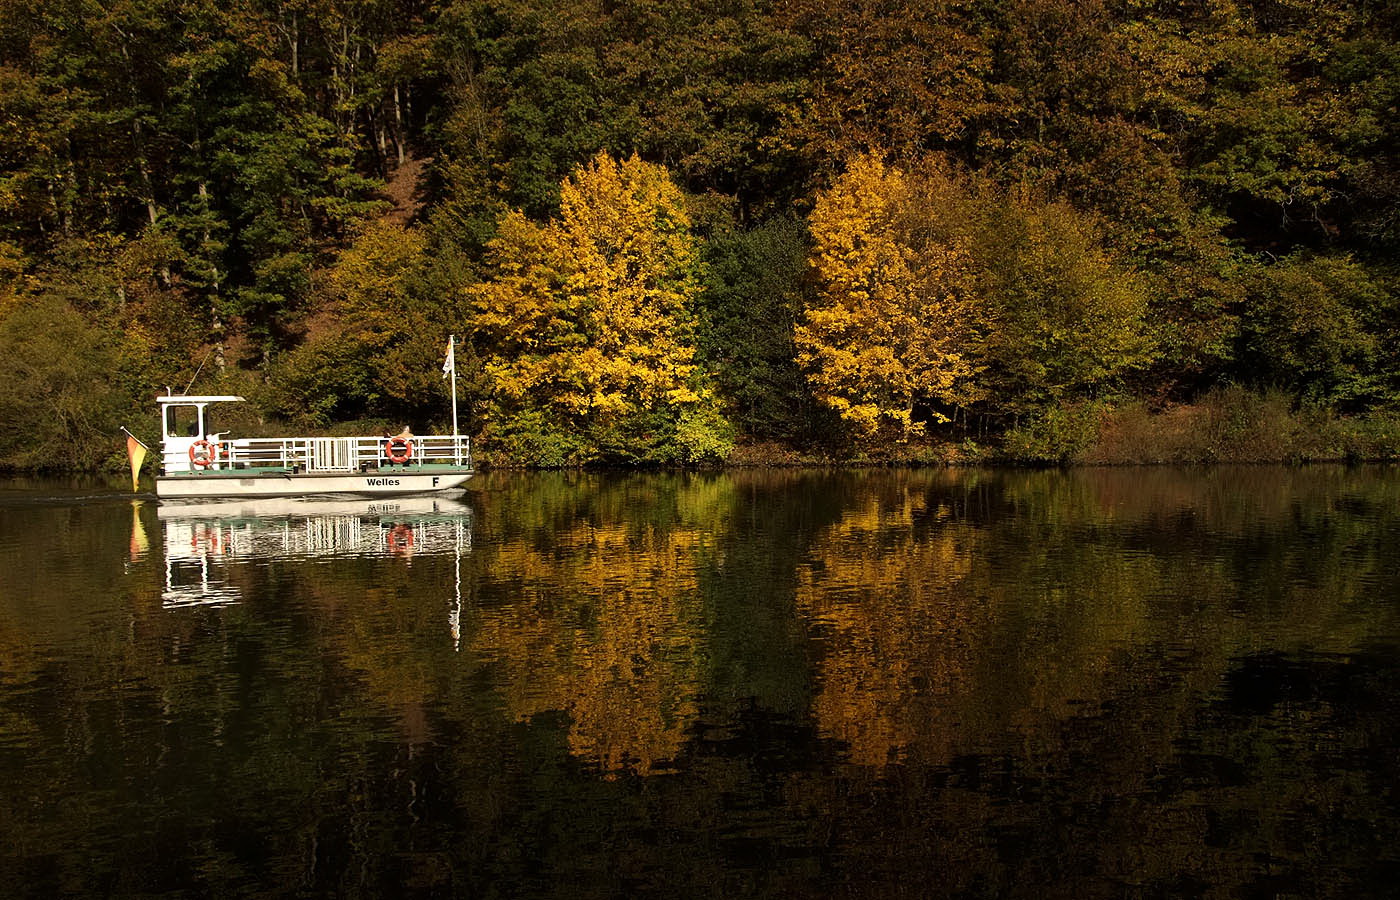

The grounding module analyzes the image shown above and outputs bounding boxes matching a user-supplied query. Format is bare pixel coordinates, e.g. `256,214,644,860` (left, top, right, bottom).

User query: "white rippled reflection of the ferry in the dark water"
151,495,472,607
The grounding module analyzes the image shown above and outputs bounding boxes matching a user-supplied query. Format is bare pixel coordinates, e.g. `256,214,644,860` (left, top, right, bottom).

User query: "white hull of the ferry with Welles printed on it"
155,469,473,498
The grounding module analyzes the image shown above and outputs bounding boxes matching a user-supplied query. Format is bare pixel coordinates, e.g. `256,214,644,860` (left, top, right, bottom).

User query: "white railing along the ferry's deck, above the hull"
164,434,472,472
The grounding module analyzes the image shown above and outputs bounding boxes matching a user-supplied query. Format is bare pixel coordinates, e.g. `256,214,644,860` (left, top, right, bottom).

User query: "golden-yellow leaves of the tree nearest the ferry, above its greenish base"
470,154,711,436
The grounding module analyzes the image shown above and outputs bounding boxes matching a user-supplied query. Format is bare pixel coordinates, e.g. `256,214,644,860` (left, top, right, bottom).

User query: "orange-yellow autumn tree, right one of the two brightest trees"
795,155,973,440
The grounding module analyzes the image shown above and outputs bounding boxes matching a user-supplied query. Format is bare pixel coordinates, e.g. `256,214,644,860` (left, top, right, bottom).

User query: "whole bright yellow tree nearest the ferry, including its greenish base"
470,154,727,463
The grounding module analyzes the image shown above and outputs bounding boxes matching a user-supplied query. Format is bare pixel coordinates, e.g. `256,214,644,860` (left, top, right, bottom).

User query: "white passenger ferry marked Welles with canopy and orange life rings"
155,391,473,498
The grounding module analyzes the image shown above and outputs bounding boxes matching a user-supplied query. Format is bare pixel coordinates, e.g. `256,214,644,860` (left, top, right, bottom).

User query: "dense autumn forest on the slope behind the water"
0,0,1400,467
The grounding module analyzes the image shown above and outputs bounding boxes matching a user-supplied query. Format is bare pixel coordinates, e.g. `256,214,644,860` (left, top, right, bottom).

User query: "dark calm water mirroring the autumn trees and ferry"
0,467,1400,897
